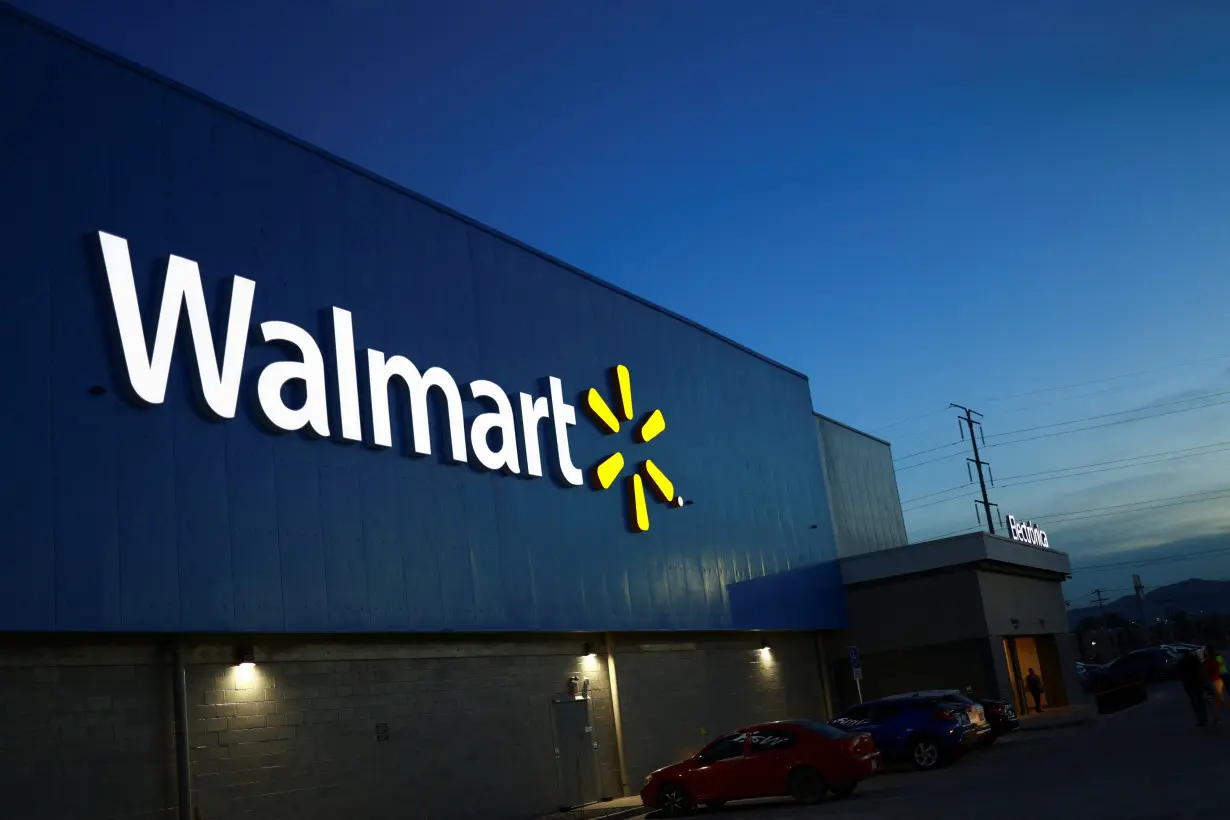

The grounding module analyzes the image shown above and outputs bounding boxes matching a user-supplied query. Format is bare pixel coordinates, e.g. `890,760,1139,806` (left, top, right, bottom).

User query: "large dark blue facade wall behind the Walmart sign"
0,7,843,632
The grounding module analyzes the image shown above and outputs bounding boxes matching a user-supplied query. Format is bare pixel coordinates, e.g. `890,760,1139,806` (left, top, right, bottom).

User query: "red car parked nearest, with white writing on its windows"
641,720,881,816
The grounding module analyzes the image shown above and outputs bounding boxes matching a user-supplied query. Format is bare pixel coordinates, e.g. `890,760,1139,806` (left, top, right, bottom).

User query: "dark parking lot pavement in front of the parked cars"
659,685,1230,820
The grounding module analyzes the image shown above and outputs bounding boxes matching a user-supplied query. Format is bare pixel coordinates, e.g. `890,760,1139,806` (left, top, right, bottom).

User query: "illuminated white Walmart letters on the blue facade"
98,231,584,487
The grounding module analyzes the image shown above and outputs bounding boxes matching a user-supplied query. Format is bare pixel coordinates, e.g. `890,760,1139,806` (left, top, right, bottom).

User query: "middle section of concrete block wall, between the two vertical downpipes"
188,638,619,820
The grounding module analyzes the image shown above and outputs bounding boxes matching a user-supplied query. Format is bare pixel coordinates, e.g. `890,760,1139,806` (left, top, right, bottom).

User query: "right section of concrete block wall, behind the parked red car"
615,633,825,793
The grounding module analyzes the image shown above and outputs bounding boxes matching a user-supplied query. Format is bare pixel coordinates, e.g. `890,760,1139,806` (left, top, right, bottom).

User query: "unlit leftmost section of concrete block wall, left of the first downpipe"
0,639,176,820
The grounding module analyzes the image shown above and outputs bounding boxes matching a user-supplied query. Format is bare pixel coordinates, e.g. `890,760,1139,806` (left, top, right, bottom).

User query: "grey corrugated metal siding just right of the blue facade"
815,417,908,558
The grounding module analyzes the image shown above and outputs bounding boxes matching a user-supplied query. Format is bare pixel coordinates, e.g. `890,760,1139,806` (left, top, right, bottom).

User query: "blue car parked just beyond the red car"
831,695,991,770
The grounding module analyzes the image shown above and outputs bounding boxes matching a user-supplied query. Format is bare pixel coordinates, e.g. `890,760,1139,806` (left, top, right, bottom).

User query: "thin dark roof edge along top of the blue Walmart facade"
0,0,809,381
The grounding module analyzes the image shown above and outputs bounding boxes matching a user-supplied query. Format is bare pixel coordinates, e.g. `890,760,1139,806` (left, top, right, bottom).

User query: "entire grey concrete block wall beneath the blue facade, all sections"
0,634,823,820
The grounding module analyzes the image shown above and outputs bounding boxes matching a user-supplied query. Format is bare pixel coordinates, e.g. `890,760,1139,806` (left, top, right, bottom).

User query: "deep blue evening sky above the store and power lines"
15,0,1230,599
